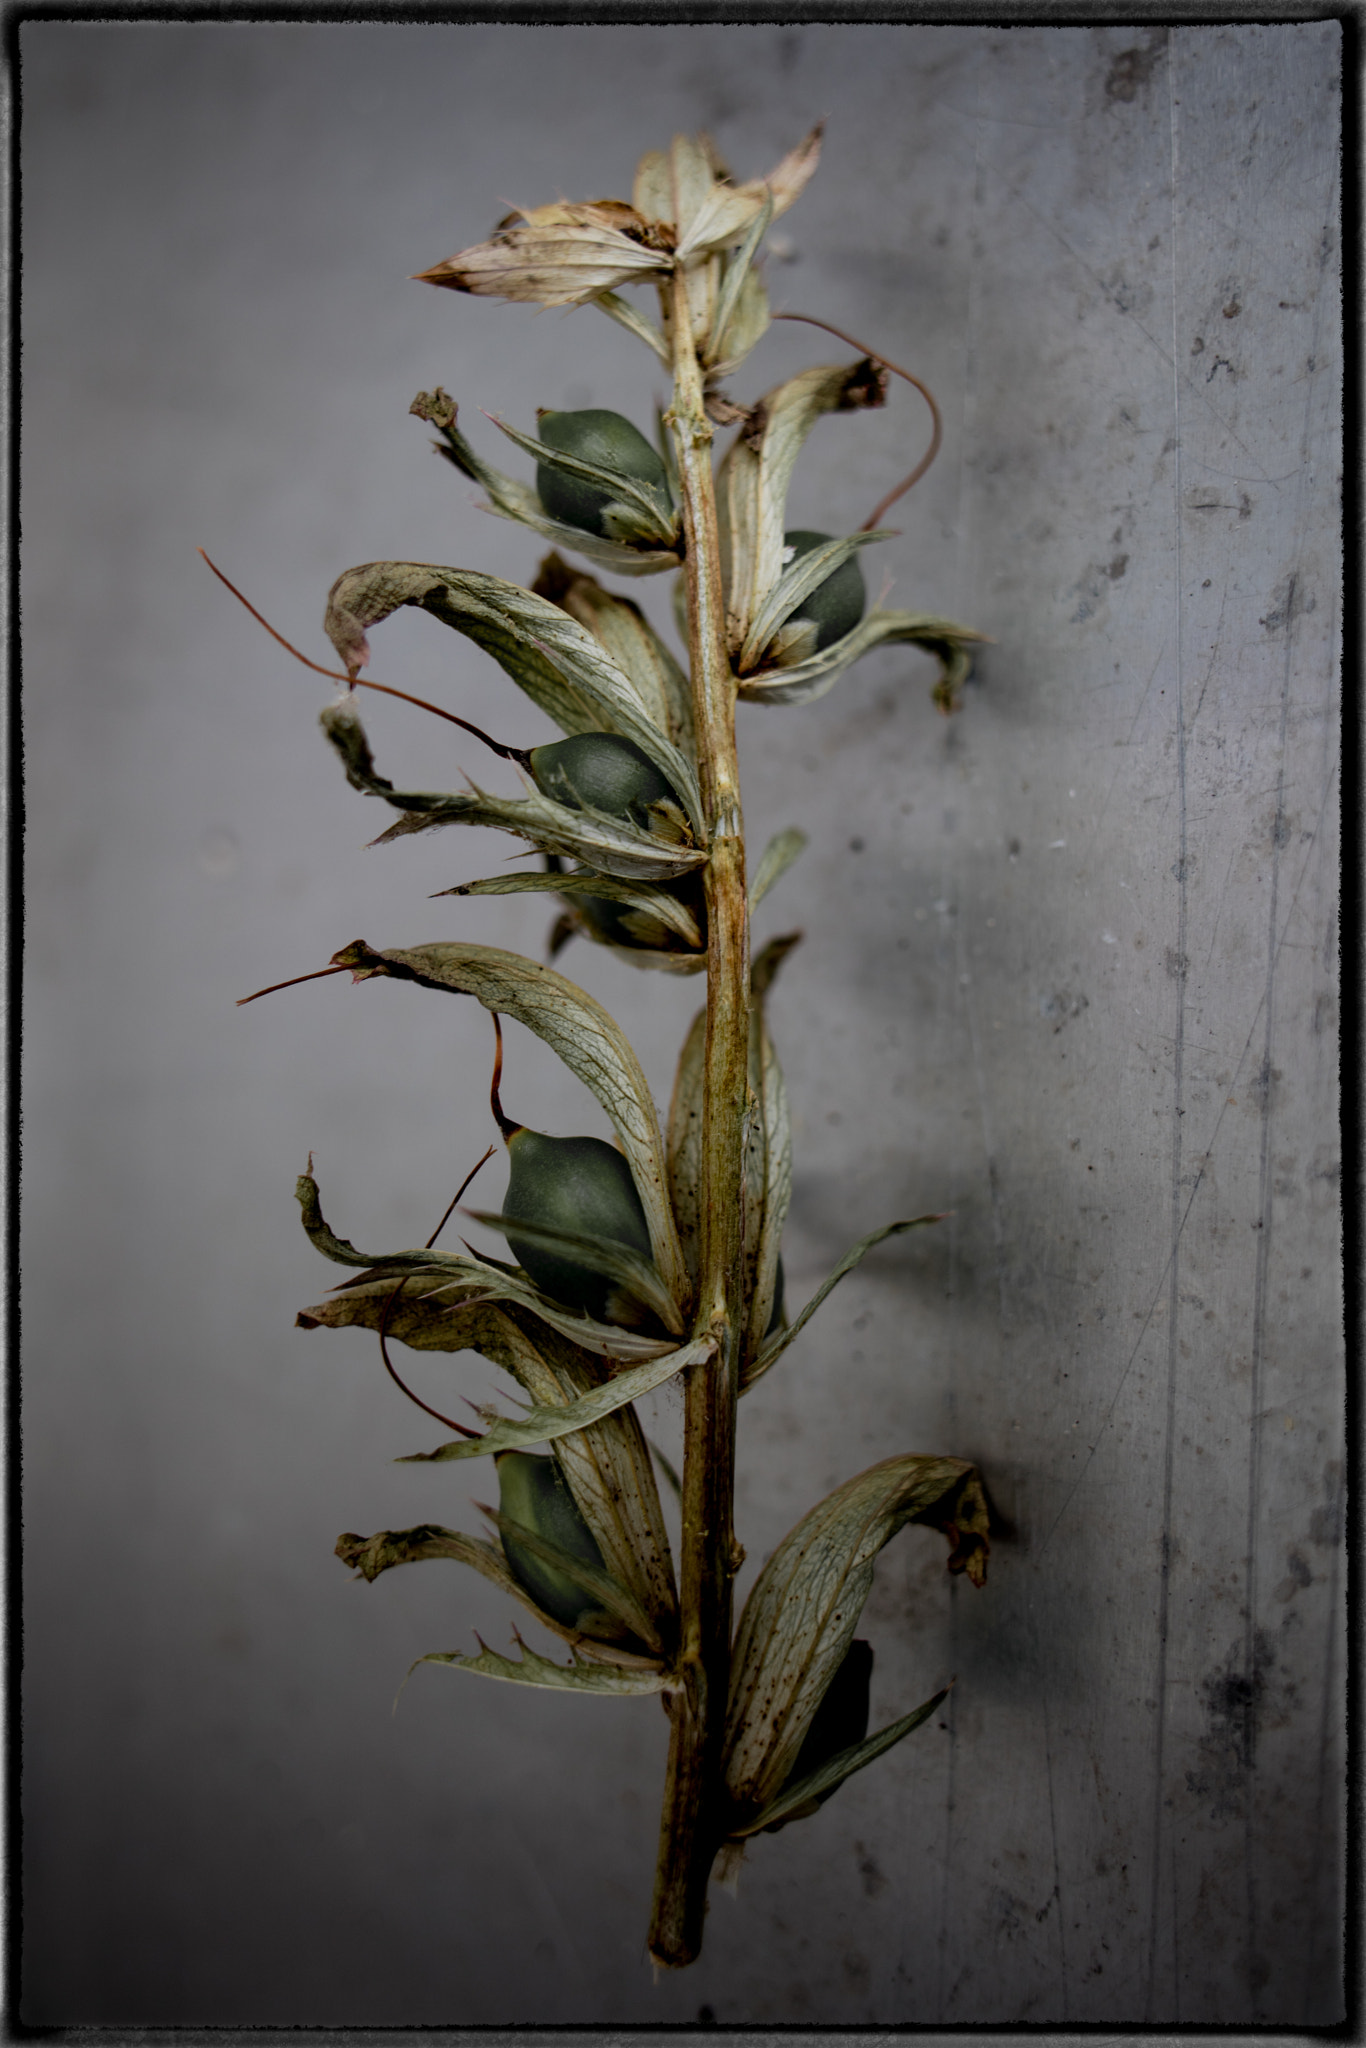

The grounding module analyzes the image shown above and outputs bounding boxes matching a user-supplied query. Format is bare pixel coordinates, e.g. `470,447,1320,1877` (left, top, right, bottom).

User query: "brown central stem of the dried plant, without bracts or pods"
649,270,750,1968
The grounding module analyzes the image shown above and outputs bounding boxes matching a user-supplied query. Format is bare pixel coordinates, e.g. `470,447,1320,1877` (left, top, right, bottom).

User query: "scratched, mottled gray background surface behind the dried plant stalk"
20,23,1341,2025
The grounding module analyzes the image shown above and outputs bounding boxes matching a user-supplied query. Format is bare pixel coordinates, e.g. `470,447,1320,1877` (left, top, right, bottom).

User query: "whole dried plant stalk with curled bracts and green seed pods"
229,129,987,1968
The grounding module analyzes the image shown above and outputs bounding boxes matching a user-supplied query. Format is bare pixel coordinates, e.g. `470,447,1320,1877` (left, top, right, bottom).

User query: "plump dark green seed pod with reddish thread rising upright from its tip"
504,1128,653,1323
